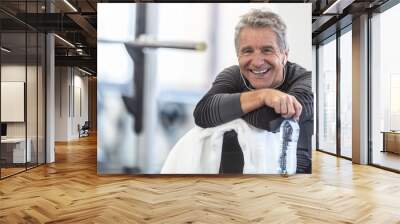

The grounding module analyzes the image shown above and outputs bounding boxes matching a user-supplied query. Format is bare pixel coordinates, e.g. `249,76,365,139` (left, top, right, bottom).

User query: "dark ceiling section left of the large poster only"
0,0,102,74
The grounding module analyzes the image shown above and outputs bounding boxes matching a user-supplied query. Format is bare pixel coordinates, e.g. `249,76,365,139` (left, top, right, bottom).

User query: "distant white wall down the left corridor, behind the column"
55,67,88,141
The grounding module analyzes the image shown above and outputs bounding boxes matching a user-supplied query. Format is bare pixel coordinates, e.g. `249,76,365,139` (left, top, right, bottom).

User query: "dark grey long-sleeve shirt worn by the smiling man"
193,62,314,173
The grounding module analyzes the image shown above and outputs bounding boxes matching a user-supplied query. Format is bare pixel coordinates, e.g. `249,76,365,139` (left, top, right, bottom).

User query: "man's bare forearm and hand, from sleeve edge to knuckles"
240,89,302,120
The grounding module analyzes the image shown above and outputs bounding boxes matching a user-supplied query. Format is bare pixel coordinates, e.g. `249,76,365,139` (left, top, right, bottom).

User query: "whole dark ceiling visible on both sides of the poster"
0,0,394,73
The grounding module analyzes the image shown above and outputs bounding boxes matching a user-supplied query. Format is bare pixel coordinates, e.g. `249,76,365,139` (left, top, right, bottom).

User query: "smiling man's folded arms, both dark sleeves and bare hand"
194,66,313,131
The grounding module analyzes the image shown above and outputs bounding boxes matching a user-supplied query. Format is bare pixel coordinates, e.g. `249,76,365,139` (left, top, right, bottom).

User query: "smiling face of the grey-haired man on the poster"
238,27,287,89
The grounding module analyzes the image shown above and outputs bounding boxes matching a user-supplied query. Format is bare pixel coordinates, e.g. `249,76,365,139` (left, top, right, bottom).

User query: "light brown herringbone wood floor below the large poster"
0,134,400,224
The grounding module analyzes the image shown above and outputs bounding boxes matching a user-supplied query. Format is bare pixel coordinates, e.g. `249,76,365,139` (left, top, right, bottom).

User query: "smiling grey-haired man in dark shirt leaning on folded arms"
194,9,314,173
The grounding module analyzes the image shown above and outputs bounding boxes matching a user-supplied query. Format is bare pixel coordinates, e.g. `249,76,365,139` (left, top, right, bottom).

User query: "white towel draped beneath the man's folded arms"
161,119,299,174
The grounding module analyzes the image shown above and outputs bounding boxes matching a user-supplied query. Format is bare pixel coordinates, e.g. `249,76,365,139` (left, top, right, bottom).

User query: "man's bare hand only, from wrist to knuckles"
262,89,302,120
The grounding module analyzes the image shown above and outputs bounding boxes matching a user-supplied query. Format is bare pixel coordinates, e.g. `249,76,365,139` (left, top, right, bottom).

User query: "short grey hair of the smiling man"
235,9,289,54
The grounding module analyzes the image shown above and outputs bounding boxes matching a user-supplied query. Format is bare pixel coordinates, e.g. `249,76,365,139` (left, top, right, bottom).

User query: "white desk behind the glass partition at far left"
1,138,32,163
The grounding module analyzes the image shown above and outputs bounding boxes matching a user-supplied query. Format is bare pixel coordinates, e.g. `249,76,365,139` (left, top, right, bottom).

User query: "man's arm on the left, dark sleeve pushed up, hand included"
193,66,301,131
